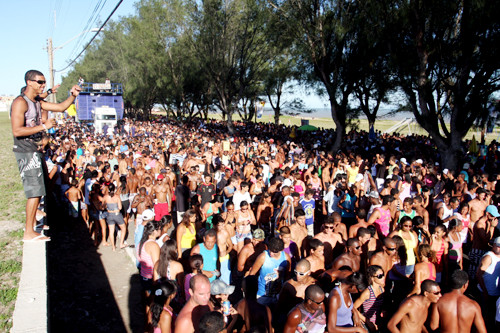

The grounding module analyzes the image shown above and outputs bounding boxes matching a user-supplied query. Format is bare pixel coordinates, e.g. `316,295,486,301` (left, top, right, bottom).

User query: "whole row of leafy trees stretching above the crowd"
59,0,500,167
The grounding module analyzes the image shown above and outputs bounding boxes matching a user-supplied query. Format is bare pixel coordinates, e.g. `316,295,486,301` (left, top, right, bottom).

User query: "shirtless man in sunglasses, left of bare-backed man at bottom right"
387,280,441,333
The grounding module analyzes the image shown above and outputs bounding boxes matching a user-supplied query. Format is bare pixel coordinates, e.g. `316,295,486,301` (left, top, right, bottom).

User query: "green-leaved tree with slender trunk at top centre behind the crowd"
193,0,267,134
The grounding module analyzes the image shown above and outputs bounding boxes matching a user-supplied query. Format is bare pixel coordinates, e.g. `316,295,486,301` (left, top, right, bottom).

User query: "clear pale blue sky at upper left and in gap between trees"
0,0,328,108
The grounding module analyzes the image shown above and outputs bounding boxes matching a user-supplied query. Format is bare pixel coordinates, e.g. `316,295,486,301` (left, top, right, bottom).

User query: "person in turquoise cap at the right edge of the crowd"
469,205,500,280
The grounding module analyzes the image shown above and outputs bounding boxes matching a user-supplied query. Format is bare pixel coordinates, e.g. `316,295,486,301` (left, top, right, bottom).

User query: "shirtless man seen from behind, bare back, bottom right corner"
430,270,487,333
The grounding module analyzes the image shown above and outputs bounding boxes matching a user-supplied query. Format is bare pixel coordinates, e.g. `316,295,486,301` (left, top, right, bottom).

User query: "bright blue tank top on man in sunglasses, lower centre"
257,250,288,296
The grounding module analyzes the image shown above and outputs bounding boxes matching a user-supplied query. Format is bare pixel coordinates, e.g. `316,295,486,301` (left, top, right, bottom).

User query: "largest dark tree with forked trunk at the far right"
386,0,500,169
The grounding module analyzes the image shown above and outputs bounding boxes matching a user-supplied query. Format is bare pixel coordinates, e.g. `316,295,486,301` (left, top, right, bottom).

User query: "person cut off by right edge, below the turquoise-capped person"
476,237,500,332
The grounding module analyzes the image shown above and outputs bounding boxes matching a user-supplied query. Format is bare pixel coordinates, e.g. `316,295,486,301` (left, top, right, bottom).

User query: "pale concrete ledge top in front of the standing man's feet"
11,241,48,333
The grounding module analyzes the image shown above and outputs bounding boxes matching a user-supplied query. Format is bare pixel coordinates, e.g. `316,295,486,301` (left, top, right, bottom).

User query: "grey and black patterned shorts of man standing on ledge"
14,152,46,199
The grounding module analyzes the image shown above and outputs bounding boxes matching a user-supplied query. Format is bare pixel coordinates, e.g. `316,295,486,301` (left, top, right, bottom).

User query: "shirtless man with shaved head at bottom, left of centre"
175,274,213,333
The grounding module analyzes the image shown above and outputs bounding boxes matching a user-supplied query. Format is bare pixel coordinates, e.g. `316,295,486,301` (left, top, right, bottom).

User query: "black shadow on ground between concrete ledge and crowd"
47,201,137,332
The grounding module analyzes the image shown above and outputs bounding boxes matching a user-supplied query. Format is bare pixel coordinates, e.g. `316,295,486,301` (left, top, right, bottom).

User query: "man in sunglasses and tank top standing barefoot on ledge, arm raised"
10,70,81,241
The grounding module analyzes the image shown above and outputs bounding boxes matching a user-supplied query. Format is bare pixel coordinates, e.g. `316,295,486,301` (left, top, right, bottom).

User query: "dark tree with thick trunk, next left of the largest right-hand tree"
273,0,359,151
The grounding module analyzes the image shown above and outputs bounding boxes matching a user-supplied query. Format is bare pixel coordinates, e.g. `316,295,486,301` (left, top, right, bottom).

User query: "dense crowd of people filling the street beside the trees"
10,68,500,333
